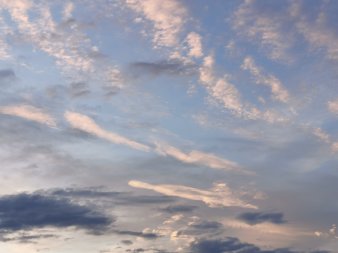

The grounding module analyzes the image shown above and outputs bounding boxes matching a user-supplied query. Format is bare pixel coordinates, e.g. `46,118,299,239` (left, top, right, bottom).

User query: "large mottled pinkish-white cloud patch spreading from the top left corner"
0,0,123,88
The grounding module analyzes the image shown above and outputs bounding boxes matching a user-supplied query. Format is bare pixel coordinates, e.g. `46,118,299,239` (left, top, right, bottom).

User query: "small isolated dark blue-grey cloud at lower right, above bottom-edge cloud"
237,212,286,225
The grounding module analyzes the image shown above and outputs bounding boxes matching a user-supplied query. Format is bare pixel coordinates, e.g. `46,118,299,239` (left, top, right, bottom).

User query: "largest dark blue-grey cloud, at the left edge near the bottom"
0,194,114,234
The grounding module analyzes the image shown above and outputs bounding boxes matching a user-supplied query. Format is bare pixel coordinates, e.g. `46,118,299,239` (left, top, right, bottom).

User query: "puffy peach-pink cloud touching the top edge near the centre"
125,0,187,47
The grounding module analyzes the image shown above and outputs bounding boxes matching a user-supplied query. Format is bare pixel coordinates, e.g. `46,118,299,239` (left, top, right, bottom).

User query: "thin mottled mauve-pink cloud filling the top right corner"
232,1,338,62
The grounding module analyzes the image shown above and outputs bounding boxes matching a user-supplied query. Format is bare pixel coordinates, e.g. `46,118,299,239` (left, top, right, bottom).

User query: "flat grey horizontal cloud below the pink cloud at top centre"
129,60,196,77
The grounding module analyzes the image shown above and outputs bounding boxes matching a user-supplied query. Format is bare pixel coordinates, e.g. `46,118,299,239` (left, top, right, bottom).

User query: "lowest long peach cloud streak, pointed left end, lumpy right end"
128,180,257,209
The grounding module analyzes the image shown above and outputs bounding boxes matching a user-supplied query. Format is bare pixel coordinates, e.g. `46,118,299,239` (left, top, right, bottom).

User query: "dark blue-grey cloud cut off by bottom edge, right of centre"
190,237,329,253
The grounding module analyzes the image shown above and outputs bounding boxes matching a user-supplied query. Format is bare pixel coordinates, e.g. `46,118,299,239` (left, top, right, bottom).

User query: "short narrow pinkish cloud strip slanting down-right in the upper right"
241,56,289,103
